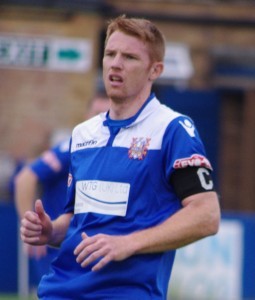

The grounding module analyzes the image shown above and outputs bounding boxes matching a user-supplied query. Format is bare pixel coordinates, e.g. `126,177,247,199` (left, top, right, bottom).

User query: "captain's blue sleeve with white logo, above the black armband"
162,116,212,180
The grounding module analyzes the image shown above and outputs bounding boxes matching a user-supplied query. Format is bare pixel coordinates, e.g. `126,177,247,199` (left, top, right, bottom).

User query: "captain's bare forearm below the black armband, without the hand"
128,192,220,254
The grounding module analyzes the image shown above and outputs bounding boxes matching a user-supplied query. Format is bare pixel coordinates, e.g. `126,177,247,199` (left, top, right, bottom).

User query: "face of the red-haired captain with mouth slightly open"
103,31,151,102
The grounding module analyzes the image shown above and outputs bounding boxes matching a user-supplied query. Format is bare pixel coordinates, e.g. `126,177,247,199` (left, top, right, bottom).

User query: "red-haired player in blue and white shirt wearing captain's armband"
20,16,220,300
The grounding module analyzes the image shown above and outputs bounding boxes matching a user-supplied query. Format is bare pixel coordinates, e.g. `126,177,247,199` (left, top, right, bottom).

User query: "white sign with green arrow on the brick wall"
0,35,92,72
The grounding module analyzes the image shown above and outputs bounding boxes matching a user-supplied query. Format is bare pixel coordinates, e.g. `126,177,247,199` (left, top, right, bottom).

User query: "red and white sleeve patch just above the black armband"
174,154,212,170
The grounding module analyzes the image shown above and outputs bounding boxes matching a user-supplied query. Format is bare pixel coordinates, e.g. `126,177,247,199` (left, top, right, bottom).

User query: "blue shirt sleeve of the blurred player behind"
30,140,70,183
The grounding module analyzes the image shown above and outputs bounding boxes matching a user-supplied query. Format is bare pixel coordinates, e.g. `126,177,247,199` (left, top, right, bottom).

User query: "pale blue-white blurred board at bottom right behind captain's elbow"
168,220,243,300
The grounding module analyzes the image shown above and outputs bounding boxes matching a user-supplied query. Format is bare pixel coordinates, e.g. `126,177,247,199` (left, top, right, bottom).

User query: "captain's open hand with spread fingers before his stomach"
74,232,133,271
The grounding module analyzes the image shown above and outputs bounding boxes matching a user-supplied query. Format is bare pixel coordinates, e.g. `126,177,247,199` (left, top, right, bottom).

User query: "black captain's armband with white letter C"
170,167,214,200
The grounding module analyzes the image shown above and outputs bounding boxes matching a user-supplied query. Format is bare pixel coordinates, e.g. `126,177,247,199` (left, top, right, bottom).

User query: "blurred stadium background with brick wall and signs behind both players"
0,0,255,300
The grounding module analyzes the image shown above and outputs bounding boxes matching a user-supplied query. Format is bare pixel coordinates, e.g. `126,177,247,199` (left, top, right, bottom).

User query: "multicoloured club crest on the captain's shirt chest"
128,137,151,160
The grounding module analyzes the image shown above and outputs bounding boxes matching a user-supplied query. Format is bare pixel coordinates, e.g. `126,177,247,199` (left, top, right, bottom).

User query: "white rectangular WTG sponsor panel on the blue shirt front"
74,180,130,216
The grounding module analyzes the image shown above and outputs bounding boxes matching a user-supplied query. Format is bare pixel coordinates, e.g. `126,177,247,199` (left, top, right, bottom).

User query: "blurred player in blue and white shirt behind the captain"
14,92,109,284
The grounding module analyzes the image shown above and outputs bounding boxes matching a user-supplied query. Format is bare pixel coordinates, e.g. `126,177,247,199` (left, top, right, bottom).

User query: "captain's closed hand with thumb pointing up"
20,200,52,245
